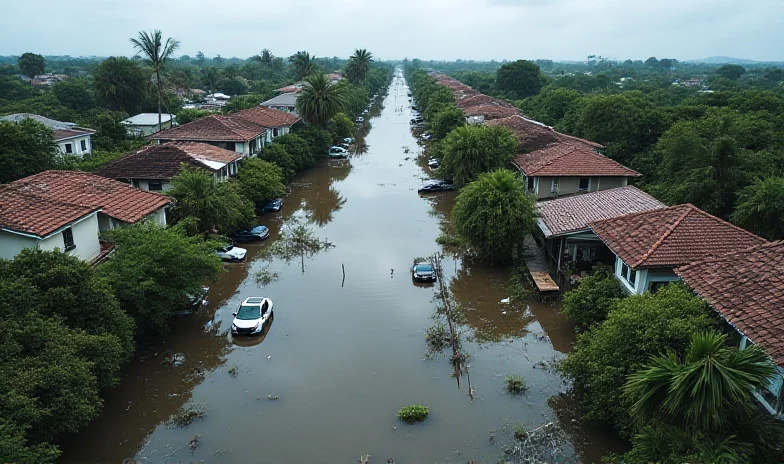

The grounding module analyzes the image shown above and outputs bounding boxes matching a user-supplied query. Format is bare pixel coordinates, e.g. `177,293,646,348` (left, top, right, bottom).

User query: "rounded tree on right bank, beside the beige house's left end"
439,126,517,186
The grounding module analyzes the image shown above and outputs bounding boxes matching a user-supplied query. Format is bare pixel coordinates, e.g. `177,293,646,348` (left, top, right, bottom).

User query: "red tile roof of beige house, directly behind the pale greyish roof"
512,142,640,177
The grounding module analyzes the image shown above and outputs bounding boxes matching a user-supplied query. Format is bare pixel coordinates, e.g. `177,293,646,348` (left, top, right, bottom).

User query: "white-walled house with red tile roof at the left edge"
0,171,169,262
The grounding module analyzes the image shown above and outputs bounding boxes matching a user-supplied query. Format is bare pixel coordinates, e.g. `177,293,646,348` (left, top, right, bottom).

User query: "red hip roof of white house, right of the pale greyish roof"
589,204,767,268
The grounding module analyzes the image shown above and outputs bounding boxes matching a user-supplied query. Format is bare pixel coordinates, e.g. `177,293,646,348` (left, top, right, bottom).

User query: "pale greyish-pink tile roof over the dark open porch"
536,185,667,237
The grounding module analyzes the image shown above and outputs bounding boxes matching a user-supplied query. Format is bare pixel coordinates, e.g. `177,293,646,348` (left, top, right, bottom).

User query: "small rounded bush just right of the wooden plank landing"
562,269,626,330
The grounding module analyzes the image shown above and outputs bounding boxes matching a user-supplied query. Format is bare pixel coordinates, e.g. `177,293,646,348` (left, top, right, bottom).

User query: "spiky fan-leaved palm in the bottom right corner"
624,332,784,463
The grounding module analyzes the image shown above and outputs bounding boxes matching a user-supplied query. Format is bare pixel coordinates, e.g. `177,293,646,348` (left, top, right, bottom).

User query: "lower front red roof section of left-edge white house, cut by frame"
0,185,100,238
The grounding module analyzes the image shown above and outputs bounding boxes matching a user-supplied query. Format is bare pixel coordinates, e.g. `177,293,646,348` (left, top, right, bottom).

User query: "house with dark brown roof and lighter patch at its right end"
95,142,242,192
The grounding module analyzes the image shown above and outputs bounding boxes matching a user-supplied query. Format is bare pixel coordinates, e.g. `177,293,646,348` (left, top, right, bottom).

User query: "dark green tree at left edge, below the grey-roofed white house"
0,118,57,183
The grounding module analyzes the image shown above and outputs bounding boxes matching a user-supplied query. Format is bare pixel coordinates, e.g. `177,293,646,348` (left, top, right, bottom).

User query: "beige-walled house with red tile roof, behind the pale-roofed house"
512,141,640,200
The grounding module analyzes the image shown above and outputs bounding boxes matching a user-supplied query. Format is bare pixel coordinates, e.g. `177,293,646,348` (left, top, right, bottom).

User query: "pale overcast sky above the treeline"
0,0,784,60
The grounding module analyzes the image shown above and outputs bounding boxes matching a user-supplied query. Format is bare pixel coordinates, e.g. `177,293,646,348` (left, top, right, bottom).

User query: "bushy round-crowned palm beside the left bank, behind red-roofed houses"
297,74,346,127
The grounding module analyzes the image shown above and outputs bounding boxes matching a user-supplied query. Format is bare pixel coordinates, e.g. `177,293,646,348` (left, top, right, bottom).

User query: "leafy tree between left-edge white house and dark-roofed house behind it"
168,168,255,234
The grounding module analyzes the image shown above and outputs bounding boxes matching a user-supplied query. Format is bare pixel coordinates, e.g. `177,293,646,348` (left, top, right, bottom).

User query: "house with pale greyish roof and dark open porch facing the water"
536,185,666,272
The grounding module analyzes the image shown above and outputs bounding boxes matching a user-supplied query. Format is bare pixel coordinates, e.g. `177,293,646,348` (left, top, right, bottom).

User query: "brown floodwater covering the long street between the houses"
62,72,619,463
